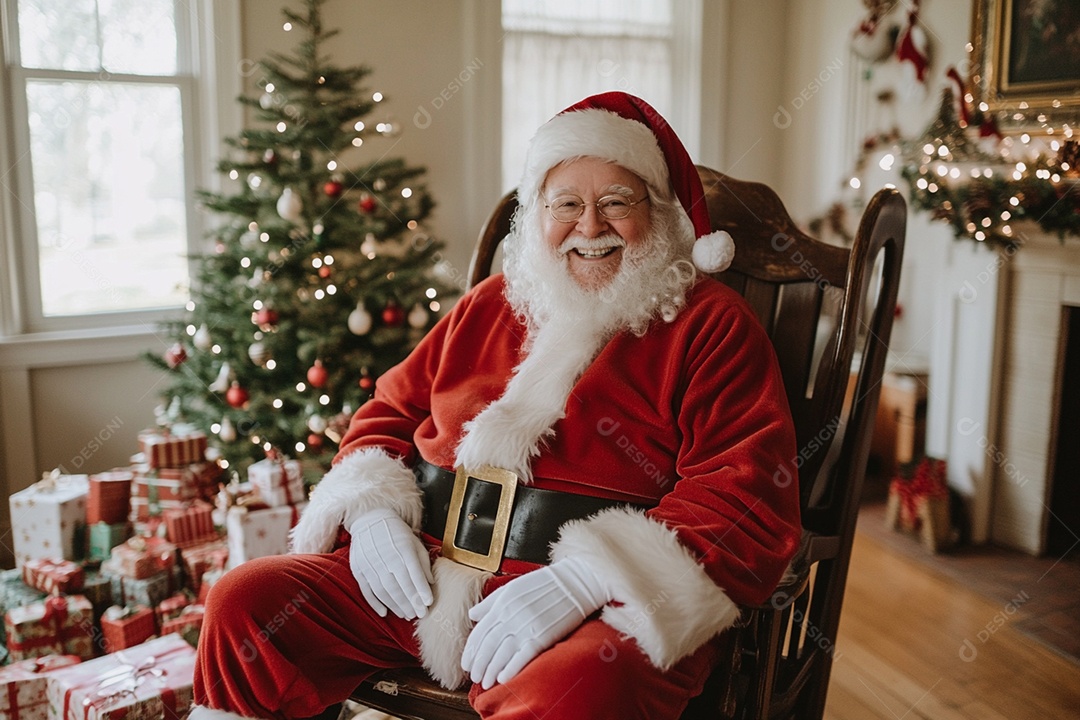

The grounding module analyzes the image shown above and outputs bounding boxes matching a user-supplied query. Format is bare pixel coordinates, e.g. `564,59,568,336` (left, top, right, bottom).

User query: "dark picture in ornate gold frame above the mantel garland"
971,0,1080,127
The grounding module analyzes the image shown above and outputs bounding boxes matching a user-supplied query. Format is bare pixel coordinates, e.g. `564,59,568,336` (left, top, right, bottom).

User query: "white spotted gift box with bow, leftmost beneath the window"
9,472,89,566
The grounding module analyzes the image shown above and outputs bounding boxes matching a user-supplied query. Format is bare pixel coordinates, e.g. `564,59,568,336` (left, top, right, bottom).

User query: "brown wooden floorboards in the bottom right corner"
825,533,1080,720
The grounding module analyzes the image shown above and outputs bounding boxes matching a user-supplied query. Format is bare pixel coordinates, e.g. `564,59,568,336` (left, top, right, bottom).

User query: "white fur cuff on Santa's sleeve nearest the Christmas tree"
289,448,423,553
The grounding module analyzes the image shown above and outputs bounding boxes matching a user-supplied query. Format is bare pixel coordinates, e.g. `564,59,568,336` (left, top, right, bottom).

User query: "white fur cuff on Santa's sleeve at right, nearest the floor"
551,508,739,670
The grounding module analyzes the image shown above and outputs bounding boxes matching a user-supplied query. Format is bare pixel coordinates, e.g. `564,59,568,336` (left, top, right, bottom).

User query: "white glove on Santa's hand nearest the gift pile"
349,508,434,620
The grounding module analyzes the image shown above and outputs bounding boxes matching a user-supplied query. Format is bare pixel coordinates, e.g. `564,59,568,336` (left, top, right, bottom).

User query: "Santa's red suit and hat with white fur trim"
192,93,800,720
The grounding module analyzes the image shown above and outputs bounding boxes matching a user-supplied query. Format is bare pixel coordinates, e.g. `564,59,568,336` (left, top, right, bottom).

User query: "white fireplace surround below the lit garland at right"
927,223,1080,555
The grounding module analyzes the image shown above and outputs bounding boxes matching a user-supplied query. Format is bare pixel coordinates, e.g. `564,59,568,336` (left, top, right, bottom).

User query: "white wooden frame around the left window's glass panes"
0,0,242,343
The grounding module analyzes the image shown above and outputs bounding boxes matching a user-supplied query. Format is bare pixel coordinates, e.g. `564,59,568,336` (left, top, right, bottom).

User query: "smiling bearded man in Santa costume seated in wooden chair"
191,93,800,720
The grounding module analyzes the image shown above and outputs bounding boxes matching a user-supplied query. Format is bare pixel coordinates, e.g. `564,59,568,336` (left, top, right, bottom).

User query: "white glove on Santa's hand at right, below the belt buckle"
461,557,611,690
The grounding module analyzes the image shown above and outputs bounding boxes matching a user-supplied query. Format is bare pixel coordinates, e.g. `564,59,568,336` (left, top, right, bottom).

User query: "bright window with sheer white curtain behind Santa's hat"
502,0,702,189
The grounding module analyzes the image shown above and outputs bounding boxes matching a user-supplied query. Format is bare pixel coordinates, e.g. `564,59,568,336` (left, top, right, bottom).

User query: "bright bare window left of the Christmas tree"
2,0,205,330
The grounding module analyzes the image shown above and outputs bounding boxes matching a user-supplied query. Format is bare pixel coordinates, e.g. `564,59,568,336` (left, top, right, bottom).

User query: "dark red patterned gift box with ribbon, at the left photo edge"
4,595,94,660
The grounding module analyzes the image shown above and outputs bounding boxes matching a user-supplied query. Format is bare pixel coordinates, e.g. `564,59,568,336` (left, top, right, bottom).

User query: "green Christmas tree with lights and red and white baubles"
148,0,445,471
